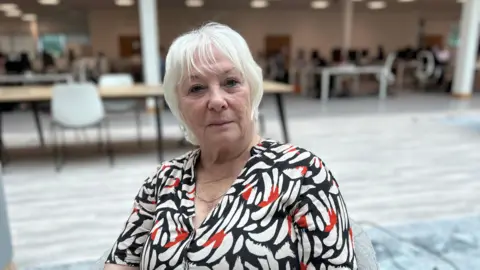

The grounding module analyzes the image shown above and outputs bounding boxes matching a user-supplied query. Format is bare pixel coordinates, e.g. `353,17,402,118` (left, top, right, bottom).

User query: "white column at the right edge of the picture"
452,0,480,98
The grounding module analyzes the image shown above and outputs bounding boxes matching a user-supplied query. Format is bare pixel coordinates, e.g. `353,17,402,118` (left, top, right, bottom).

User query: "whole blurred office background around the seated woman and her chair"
0,0,480,270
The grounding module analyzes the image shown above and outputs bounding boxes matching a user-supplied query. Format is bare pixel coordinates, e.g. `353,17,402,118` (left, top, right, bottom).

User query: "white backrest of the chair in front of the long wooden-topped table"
51,83,105,128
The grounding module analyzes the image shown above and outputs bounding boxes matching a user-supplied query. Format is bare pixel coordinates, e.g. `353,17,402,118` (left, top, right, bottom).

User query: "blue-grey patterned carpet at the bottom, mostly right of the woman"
22,216,480,270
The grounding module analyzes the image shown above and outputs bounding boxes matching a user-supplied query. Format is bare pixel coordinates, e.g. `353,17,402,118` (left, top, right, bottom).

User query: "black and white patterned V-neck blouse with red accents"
106,140,357,270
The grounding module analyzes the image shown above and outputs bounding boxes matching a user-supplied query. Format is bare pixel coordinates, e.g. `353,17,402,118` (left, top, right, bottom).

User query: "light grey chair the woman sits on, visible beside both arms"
92,220,380,270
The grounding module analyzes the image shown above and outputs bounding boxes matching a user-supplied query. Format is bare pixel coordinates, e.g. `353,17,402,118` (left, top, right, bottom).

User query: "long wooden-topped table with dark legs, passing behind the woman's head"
0,81,293,161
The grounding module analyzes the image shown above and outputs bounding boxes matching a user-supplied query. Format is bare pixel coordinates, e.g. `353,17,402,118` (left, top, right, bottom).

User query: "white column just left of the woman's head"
138,0,160,108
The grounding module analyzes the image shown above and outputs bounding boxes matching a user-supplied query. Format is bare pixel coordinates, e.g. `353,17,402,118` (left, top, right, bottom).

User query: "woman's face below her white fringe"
177,48,254,146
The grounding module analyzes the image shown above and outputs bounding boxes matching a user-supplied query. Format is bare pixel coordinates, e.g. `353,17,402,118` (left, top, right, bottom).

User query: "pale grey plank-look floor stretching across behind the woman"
0,93,480,267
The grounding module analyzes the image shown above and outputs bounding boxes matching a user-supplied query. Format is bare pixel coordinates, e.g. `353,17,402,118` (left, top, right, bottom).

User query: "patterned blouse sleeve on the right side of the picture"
293,157,357,269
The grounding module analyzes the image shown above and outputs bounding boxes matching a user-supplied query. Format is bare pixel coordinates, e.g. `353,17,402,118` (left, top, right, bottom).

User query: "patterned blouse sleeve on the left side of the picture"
105,169,159,267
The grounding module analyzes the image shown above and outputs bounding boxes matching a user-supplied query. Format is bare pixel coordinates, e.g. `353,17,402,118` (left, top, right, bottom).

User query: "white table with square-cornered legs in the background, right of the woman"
321,65,387,101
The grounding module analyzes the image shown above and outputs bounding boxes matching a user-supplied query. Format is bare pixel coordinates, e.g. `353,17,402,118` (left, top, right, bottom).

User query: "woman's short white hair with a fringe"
163,22,263,145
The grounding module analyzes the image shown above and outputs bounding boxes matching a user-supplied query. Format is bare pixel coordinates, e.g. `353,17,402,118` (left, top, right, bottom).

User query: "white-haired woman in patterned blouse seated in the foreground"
105,23,356,270
